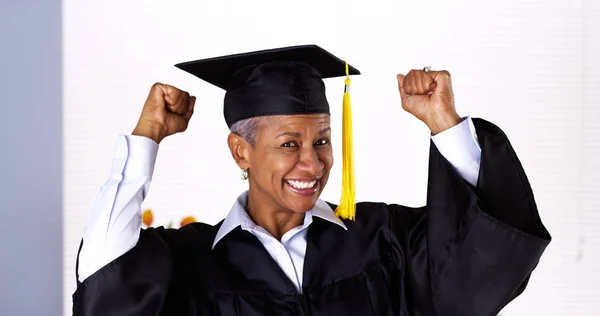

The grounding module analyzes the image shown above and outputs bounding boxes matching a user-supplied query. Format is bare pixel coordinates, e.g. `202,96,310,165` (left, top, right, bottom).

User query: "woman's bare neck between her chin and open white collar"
246,191,305,241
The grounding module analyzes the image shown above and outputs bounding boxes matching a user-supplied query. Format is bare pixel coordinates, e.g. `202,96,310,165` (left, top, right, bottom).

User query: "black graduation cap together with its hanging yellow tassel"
175,45,360,219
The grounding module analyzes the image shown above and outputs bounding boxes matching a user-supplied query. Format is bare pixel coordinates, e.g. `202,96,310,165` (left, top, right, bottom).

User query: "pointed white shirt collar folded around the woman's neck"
212,191,348,248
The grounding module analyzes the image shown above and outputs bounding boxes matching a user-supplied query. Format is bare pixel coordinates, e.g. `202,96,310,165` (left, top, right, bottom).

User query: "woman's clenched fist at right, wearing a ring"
397,70,461,134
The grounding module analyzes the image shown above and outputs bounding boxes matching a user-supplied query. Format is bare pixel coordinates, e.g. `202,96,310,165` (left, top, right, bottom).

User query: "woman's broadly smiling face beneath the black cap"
248,114,333,212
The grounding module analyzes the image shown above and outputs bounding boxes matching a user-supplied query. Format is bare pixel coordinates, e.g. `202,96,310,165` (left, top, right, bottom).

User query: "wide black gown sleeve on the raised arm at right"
390,119,551,316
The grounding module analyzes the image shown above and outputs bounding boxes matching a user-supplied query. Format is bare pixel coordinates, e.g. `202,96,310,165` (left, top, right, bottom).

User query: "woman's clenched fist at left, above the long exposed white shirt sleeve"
133,83,196,144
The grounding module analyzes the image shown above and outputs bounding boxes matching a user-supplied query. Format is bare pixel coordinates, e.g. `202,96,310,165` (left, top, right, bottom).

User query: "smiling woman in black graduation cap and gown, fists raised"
73,46,550,316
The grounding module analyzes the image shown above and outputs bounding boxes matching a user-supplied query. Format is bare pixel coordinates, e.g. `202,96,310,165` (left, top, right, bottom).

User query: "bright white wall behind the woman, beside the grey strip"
63,0,600,315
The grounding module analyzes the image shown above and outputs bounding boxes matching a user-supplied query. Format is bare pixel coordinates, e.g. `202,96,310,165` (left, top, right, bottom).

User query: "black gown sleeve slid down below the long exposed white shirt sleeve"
73,228,175,316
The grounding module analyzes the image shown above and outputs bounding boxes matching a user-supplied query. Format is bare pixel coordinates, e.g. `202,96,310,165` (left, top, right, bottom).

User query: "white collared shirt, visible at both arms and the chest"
78,118,481,291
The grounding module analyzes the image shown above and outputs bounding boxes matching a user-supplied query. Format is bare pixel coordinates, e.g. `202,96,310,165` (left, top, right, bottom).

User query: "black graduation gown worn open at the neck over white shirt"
73,119,550,316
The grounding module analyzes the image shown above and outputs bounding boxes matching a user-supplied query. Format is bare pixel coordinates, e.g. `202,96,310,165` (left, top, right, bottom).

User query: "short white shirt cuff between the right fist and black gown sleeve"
431,117,481,186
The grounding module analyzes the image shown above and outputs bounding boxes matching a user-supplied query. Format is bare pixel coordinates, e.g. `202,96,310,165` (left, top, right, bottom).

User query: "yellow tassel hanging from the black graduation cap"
335,63,356,220
